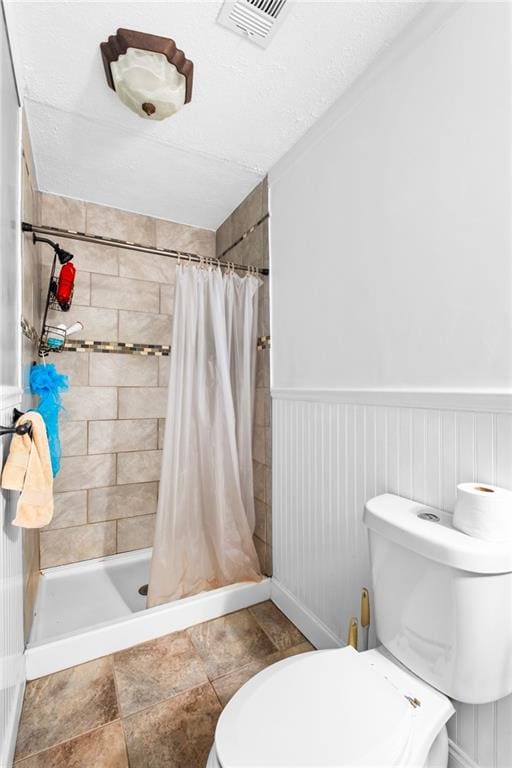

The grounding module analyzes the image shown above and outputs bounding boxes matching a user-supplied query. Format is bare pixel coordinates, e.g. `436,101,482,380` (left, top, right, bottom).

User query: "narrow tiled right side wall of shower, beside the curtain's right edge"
216,179,272,575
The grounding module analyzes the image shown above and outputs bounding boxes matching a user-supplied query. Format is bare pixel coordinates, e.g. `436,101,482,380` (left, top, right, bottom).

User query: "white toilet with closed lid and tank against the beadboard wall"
207,494,512,768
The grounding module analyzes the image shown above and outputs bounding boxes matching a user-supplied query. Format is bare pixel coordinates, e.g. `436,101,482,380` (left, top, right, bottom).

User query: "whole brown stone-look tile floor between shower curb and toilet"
15,601,312,768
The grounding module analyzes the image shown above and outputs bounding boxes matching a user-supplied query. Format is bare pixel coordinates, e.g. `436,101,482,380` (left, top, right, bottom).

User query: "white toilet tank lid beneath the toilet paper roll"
363,493,512,573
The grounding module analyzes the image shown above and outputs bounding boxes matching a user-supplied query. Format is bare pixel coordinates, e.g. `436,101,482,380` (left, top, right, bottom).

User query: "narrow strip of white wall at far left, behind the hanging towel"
0,7,25,768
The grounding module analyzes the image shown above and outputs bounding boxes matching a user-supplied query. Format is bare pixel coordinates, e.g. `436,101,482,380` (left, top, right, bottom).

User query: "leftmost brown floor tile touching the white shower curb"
16,656,118,760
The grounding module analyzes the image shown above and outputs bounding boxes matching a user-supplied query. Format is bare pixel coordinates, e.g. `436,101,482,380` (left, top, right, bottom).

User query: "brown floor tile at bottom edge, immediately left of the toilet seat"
124,683,221,768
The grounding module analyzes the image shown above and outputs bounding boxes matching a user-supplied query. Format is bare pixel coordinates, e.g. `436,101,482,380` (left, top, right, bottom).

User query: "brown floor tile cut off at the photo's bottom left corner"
16,720,128,768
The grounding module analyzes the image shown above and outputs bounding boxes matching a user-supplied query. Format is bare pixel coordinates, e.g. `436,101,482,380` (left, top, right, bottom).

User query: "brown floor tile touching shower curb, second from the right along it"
187,610,276,680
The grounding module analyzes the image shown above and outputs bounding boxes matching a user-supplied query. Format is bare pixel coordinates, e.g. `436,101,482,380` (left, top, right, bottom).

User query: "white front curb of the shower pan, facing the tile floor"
25,579,270,680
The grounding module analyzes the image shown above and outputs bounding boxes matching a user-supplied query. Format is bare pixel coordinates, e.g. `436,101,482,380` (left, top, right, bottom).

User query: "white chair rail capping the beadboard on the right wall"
271,387,512,413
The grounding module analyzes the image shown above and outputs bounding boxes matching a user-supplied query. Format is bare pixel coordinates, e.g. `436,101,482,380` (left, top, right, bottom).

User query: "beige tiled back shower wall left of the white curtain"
40,194,215,568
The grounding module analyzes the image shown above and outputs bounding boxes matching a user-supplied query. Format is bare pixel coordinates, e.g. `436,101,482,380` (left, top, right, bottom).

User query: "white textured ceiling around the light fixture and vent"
6,0,423,229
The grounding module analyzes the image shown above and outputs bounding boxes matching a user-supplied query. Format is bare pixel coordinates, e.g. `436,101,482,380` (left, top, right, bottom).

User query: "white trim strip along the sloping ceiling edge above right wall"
268,2,464,187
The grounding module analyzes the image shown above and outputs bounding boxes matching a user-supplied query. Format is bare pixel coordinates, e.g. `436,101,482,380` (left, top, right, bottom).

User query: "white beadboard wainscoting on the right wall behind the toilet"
272,389,512,768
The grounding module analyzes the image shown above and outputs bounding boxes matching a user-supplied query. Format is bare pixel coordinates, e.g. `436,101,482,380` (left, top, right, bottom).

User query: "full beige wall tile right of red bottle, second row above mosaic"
91,274,160,314
